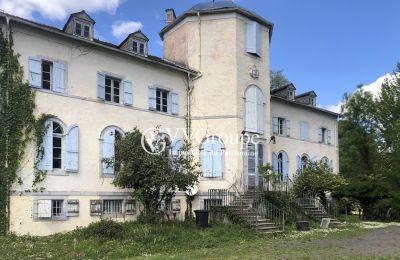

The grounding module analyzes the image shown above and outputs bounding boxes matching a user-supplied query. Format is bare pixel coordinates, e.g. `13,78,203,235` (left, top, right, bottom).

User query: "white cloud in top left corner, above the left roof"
0,0,121,20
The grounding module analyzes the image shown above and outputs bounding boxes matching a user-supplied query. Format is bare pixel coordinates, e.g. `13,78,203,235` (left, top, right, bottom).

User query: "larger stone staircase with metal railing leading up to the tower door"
209,190,284,233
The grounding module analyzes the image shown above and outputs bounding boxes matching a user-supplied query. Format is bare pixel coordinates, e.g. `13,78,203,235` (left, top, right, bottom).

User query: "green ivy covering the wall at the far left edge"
0,30,35,235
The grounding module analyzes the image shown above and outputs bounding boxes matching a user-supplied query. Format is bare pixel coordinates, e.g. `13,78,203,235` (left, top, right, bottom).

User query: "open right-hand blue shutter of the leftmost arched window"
65,125,79,172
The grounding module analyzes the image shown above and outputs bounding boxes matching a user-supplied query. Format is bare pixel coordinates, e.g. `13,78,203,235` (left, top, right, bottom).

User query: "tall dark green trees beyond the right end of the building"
339,65,400,219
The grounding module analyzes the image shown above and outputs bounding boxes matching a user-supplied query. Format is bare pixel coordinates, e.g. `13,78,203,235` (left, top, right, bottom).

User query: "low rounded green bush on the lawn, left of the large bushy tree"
82,219,123,239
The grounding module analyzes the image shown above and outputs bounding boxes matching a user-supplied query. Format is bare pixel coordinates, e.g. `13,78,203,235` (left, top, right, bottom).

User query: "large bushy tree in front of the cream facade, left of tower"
107,128,200,221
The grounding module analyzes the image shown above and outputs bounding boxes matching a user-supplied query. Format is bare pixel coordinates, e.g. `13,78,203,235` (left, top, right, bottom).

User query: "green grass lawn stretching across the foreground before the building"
0,222,400,259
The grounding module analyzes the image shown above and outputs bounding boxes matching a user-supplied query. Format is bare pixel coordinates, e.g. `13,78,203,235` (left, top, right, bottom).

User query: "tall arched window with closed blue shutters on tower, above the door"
244,85,265,134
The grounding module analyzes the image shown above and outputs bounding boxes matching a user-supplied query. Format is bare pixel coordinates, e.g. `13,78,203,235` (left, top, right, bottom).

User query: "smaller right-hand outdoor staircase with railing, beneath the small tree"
297,194,345,228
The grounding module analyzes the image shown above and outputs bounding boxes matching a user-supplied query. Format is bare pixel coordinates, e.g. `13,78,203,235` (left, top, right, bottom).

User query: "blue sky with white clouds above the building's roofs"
0,0,400,111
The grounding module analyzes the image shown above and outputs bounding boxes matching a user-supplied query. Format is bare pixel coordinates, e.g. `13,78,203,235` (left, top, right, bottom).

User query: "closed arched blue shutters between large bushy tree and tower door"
200,136,225,178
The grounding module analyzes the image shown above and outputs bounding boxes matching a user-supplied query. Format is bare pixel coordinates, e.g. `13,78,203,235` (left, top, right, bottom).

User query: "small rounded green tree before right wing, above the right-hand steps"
293,161,346,205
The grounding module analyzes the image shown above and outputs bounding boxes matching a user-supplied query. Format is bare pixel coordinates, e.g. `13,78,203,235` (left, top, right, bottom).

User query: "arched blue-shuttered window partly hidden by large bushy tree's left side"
100,126,124,175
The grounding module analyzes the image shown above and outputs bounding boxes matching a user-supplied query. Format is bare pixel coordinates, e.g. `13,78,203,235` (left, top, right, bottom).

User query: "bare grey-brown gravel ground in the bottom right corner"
303,226,400,257
